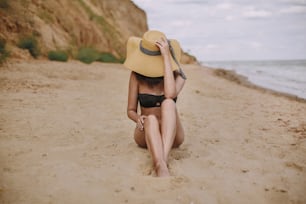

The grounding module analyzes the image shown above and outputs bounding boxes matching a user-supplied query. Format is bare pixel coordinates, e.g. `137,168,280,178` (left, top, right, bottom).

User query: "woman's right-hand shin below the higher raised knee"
161,99,177,162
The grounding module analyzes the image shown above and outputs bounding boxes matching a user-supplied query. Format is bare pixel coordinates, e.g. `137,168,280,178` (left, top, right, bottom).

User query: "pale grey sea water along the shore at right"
202,60,306,99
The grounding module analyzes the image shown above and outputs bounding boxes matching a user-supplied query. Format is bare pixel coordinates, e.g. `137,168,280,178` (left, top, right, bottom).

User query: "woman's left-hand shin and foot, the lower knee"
139,115,169,177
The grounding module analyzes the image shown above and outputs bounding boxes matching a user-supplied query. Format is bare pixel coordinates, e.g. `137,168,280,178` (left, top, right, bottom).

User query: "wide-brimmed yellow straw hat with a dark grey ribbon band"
124,30,181,77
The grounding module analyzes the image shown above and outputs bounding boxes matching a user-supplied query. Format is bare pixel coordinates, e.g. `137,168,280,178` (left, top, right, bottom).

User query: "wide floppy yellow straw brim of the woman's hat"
124,37,181,77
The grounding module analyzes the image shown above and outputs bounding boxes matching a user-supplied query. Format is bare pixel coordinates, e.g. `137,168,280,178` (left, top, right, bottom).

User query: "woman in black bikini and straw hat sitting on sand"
124,31,186,177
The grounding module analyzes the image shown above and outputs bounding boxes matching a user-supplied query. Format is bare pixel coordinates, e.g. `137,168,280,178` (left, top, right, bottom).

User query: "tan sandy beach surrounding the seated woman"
0,60,306,204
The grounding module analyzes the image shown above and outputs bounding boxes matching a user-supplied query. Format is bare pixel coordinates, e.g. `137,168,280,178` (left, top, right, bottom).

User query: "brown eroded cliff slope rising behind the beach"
0,0,195,62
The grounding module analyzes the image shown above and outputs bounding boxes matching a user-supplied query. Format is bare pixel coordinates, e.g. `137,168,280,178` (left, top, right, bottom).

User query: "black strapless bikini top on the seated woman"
138,93,177,108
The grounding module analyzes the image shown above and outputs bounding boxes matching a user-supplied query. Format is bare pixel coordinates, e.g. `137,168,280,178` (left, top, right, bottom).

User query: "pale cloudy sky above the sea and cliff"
133,0,306,62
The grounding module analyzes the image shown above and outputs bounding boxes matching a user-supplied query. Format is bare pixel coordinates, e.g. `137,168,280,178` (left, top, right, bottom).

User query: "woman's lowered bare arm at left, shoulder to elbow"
127,72,139,123
